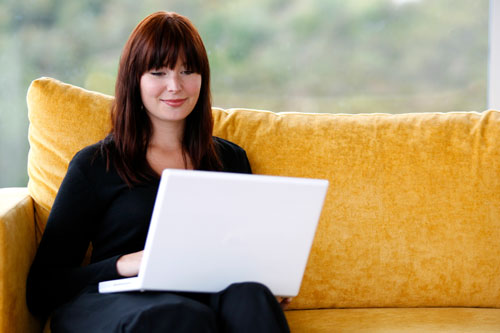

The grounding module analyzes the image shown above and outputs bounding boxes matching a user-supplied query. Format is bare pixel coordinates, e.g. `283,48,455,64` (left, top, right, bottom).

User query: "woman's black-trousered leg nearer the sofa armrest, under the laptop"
51,290,216,333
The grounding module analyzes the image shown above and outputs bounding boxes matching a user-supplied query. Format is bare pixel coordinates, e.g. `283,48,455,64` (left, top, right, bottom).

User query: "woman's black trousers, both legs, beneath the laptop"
51,282,290,333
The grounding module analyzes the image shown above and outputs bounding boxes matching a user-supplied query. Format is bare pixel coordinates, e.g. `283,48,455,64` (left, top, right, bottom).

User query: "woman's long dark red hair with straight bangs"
104,11,221,186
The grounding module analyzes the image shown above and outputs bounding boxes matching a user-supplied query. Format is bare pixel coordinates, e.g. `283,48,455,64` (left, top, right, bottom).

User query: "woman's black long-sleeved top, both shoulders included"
26,137,251,316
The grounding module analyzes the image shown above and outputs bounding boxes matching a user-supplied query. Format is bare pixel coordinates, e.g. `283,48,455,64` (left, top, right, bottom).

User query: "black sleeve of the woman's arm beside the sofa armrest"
26,150,119,316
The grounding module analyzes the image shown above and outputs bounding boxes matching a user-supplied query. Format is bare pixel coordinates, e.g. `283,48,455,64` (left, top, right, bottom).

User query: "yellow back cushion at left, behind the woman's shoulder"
27,78,113,240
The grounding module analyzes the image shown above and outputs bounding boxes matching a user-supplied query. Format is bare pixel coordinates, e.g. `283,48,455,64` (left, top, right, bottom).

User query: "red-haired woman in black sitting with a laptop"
27,12,288,332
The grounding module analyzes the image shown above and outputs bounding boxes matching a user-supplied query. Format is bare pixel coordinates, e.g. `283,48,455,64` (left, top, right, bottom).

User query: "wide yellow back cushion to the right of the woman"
215,110,500,309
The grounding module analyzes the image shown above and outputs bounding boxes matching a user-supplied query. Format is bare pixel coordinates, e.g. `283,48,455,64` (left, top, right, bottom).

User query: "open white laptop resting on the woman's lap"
99,169,328,296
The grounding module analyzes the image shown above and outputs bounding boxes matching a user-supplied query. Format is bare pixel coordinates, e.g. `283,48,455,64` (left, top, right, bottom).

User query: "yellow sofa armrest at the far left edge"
0,188,41,332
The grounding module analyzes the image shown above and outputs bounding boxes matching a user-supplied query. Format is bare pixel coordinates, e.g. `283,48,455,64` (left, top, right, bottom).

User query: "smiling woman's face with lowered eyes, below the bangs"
140,60,201,124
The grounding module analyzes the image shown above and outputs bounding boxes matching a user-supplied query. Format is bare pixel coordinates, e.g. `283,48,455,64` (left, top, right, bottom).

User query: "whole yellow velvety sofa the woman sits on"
0,78,500,332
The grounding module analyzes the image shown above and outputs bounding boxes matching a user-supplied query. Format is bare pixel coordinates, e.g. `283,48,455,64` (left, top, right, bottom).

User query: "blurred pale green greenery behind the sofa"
0,0,488,187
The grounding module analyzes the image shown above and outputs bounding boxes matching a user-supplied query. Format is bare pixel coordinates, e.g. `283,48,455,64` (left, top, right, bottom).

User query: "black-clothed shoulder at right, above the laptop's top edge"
214,137,252,173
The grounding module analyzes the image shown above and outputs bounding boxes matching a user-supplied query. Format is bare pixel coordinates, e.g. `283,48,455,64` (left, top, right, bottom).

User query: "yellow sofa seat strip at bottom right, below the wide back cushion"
285,308,500,333
